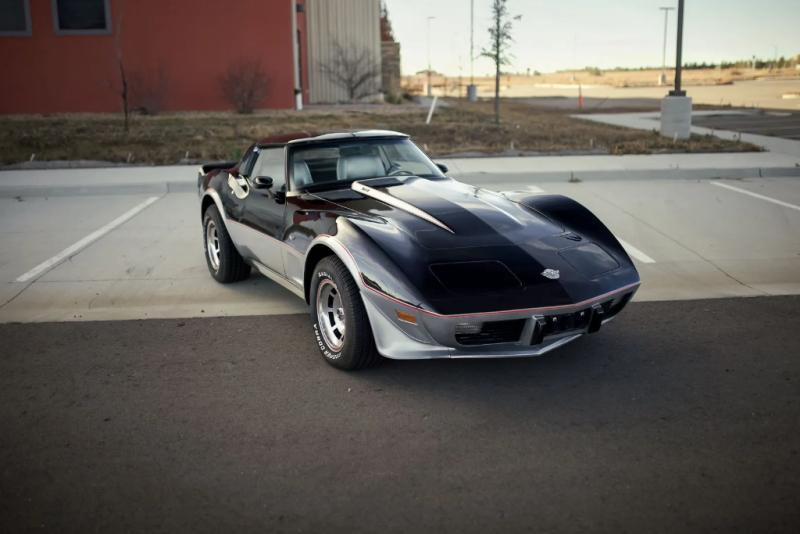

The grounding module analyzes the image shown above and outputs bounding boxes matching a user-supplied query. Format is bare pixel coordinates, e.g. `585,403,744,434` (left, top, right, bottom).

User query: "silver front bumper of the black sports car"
362,283,639,360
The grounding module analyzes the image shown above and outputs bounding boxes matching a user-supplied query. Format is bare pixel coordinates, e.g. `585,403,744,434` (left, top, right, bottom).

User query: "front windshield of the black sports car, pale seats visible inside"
290,139,444,189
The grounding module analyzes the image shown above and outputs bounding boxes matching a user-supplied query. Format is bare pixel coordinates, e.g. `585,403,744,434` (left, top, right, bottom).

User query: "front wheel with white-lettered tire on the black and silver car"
310,256,381,371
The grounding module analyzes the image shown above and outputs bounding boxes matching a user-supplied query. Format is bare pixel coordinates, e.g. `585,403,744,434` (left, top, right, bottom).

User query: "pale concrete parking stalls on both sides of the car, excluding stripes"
0,174,800,322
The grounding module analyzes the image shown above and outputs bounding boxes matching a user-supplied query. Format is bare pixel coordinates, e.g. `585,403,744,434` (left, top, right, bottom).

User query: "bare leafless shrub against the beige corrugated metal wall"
319,42,381,102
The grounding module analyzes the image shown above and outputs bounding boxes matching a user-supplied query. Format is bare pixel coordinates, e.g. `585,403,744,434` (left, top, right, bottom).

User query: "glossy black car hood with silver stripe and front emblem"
317,177,638,313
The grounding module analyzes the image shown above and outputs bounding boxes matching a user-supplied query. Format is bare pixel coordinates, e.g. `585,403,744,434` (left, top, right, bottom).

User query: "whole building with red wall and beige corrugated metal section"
0,0,392,113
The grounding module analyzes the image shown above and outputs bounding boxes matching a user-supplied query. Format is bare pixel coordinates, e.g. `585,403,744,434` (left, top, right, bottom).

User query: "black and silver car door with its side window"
241,147,286,275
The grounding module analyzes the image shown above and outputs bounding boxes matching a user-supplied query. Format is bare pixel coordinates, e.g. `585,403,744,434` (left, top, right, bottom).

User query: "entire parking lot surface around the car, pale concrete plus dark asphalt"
0,166,800,532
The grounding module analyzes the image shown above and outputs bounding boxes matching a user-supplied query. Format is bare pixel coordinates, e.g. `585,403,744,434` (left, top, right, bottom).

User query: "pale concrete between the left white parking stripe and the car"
0,193,306,322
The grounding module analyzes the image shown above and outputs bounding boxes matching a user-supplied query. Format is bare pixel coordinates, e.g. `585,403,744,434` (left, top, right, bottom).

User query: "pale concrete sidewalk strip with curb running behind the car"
0,150,800,198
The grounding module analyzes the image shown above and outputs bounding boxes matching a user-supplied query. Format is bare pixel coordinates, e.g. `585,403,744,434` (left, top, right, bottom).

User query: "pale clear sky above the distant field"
383,0,800,76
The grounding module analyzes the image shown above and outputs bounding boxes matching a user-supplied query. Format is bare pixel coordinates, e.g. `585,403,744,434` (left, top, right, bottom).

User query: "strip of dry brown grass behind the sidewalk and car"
0,100,756,164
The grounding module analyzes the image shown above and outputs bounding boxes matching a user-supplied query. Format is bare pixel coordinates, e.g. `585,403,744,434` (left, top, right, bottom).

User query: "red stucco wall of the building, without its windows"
0,0,305,113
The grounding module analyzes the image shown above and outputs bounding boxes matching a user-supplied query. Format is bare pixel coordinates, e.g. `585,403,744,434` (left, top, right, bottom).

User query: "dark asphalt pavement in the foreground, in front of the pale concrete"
0,297,800,532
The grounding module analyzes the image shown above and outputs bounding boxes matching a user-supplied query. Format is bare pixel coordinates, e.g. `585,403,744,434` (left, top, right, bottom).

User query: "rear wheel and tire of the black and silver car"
203,204,250,284
